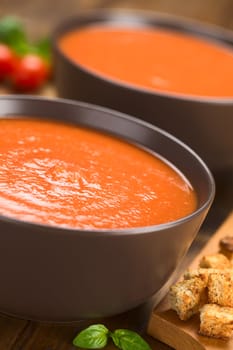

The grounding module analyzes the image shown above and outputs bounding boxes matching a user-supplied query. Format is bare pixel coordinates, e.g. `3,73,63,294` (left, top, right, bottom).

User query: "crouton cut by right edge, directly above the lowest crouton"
207,270,233,307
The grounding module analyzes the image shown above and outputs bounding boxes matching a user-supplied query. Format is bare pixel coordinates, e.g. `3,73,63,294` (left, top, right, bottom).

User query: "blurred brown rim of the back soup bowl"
52,9,233,105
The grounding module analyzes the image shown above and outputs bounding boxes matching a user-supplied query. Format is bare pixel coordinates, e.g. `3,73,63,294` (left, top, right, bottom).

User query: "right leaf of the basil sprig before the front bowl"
110,329,151,350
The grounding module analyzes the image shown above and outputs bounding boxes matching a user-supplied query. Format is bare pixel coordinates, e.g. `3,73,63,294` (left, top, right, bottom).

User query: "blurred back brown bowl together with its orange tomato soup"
54,11,233,172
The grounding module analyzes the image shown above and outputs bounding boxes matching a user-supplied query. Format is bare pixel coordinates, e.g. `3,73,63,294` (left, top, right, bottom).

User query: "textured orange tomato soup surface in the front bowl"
0,119,196,229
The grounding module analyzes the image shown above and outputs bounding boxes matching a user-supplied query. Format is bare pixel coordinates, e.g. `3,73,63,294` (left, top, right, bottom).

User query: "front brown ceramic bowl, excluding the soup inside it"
0,96,215,322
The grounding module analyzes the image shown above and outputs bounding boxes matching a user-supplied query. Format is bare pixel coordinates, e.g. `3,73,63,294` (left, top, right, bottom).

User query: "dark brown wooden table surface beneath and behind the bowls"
0,0,233,350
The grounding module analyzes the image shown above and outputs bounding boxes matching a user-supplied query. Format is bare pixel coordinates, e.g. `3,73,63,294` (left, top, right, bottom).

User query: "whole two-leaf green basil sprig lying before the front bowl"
73,324,151,350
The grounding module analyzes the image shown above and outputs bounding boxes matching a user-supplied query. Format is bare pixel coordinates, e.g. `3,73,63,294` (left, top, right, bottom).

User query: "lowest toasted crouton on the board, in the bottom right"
199,304,233,339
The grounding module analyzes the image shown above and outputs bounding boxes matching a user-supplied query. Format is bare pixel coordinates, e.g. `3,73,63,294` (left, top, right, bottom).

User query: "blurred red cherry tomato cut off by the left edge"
0,43,17,80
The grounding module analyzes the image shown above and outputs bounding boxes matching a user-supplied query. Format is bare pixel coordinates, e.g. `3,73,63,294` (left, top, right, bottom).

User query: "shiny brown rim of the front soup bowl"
0,94,216,237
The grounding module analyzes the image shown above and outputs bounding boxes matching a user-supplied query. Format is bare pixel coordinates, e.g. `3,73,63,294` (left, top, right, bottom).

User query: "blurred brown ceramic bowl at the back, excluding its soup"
53,11,233,173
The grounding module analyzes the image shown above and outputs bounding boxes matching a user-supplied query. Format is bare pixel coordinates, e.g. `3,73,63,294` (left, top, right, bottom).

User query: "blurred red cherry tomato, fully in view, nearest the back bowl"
11,54,49,91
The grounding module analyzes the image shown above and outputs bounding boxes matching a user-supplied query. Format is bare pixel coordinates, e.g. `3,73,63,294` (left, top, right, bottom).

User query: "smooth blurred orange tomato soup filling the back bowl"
59,26,233,97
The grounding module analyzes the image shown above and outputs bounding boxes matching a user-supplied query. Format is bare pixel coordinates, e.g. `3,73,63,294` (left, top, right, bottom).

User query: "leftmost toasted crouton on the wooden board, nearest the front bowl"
169,277,206,320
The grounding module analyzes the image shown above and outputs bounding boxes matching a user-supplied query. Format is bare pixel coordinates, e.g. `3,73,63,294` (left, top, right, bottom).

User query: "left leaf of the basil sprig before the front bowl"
73,324,109,349
